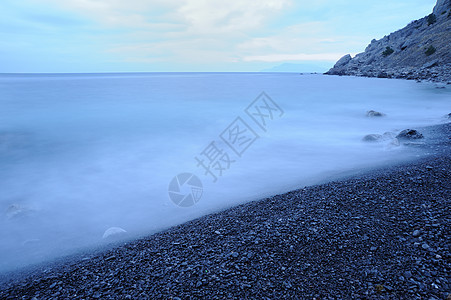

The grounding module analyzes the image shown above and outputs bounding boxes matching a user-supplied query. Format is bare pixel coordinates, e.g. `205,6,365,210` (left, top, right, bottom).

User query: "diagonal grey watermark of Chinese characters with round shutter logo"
169,92,284,207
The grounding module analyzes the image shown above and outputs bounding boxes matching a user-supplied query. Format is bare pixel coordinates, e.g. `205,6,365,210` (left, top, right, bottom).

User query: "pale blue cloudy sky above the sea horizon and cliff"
0,0,436,73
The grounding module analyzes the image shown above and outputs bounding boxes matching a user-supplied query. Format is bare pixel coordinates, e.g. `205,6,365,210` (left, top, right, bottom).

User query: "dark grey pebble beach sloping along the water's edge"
0,123,451,299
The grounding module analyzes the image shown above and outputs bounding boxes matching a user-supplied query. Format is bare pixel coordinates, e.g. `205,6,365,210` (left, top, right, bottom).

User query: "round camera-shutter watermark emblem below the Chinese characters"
168,173,204,207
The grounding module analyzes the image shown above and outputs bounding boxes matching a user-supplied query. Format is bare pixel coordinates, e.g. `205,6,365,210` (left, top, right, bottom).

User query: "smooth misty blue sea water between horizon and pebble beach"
0,73,451,271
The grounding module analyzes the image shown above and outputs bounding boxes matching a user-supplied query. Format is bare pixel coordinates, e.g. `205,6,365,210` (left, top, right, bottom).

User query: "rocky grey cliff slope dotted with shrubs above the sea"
326,0,451,83
